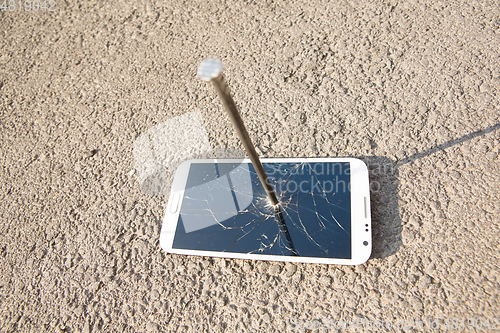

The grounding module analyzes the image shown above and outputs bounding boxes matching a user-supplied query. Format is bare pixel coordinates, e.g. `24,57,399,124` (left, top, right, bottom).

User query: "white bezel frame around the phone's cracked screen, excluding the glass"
160,158,372,265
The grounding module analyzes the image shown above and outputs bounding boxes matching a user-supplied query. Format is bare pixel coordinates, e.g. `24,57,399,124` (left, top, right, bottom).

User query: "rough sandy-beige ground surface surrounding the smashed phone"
0,0,500,332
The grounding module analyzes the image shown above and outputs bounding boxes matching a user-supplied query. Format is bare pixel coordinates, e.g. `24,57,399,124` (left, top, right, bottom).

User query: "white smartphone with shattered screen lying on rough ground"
160,158,372,265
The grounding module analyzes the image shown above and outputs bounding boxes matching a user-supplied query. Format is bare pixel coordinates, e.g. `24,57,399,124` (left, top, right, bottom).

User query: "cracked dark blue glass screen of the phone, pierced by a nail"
173,162,351,259
